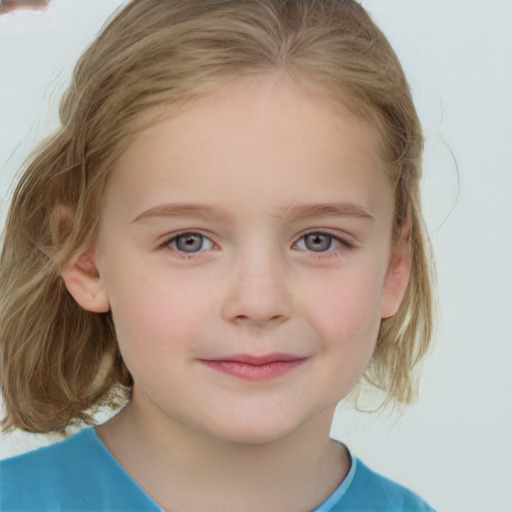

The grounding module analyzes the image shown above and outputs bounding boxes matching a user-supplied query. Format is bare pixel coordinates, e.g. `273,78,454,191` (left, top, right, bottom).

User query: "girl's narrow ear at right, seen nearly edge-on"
380,221,412,318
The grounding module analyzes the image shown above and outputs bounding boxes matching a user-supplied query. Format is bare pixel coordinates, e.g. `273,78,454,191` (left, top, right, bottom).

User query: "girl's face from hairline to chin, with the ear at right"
68,77,409,442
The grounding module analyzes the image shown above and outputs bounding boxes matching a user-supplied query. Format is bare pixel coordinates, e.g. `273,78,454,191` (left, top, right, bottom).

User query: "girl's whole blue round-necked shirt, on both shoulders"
0,428,433,512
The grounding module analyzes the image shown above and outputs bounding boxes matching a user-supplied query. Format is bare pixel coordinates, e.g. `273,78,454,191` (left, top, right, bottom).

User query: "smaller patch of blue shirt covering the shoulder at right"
332,458,435,512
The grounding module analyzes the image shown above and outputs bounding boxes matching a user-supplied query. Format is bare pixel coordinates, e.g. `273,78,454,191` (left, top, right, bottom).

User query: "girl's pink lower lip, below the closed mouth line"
203,359,306,381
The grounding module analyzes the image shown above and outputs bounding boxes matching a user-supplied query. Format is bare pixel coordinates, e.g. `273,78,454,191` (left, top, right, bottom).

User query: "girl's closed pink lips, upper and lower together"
201,353,308,381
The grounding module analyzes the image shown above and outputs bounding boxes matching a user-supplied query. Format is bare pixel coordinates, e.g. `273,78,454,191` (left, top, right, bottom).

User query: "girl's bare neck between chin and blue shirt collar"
98,394,350,512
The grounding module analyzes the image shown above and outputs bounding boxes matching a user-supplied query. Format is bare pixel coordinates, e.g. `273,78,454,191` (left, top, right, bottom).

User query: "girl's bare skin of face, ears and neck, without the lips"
63,75,410,512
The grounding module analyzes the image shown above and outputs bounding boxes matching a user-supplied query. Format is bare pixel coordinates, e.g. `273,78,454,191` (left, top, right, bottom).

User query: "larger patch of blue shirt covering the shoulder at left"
0,428,160,512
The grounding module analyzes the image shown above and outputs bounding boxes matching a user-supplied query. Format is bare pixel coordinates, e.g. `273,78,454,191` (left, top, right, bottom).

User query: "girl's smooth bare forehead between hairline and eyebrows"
106,75,391,220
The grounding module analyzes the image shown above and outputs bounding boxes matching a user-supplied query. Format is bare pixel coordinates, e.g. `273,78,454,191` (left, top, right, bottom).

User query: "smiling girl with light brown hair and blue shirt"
0,0,432,512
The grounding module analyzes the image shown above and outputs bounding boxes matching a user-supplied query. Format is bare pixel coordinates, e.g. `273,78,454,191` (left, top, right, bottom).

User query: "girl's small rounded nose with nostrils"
222,251,294,327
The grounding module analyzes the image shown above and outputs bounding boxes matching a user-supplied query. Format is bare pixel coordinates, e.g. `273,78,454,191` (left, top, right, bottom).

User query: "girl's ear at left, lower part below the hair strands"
61,248,110,313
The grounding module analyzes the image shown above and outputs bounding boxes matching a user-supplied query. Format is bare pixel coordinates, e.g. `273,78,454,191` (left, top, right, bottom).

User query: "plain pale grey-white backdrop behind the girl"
0,0,512,512
